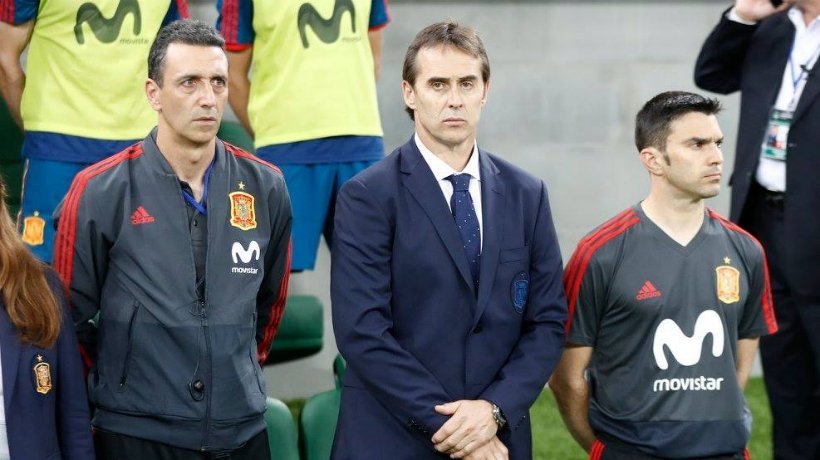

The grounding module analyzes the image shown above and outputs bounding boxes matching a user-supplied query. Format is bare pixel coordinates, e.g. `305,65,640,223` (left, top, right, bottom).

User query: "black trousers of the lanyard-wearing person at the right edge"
740,181,820,460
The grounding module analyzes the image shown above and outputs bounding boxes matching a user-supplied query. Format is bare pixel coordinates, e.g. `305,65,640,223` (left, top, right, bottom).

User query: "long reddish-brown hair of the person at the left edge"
0,177,62,348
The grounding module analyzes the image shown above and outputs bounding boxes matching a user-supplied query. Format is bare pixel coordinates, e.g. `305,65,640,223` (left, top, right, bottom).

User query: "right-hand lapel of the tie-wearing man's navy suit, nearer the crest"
474,149,506,325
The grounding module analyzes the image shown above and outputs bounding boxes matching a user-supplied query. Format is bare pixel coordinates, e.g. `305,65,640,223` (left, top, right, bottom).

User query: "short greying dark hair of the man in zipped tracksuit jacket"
148,19,225,87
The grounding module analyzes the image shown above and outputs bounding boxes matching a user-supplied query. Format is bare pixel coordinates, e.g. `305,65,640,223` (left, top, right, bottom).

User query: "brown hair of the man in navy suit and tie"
401,21,490,119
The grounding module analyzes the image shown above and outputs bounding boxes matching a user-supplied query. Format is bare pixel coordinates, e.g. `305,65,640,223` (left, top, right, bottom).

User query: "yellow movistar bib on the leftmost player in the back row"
21,0,169,140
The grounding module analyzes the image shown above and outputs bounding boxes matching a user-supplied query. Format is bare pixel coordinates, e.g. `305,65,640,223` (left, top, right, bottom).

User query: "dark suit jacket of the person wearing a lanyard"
695,12,820,302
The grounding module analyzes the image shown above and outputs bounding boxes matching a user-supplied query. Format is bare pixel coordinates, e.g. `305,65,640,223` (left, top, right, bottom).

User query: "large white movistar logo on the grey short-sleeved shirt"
652,310,725,392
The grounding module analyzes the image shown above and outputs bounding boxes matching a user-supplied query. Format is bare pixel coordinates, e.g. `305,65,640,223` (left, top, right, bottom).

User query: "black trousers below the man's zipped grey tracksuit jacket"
94,430,271,460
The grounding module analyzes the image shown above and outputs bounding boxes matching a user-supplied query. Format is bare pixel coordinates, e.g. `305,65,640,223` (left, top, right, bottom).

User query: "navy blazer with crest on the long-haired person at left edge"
0,282,94,460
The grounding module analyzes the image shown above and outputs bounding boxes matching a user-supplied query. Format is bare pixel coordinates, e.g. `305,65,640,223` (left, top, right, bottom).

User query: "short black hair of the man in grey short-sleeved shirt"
635,91,723,152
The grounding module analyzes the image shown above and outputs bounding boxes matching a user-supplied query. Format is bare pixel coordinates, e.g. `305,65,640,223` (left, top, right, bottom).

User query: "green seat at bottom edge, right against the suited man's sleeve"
299,389,342,460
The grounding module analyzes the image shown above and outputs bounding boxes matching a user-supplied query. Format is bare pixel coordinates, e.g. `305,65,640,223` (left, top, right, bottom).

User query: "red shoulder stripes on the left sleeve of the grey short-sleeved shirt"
564,209,641,334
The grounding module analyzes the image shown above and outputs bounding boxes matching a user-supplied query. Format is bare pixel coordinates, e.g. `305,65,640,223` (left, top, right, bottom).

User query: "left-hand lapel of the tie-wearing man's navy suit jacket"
400,138,475,294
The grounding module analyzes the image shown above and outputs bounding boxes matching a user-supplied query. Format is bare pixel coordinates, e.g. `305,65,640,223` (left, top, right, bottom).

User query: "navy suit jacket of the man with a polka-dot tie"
331,140,566,460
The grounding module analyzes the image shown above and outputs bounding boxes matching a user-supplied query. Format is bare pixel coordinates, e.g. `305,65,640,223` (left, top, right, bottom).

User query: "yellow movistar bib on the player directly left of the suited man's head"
248,0,382,148
